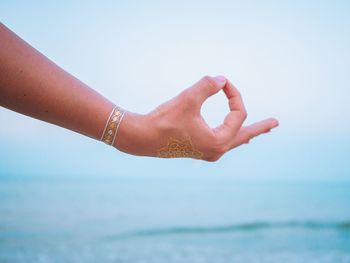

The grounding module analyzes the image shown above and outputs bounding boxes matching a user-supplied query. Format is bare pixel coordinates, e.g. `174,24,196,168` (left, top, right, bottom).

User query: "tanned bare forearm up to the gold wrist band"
0,24,114,139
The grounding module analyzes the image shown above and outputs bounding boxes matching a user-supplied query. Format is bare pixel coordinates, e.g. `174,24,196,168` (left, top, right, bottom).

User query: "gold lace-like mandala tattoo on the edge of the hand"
158,137,203,159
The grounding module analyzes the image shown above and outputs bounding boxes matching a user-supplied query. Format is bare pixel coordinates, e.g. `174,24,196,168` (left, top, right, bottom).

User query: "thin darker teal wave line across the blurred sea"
105,220,350,241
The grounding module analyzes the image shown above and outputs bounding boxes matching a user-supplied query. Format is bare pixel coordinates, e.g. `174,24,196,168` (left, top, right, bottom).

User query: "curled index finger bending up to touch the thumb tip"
216,81,247,139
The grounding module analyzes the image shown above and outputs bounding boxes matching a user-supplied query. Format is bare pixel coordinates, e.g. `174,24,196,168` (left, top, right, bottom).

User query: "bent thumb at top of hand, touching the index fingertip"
191,76,227,105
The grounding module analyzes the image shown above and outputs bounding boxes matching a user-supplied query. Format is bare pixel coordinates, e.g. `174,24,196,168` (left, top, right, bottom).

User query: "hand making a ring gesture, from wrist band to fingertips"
114,76,278,161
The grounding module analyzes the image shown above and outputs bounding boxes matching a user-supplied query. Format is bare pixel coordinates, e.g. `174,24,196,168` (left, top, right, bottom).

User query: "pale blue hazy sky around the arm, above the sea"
0,1,350,181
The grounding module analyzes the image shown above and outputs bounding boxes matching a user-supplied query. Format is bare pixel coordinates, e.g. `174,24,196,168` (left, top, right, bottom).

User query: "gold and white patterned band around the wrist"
101,106,125,146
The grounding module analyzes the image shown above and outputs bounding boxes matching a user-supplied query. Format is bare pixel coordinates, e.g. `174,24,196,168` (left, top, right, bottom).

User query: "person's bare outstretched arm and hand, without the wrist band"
0,24,278,161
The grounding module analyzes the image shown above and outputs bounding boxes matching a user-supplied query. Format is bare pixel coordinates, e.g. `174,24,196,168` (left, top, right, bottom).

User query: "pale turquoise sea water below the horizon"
0,176,350,263
